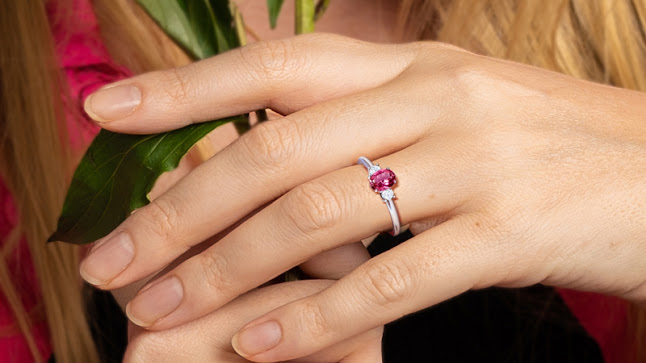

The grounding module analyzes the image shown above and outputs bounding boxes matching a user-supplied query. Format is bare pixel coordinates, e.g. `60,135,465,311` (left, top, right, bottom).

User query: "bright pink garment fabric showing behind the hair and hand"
0,0,627,363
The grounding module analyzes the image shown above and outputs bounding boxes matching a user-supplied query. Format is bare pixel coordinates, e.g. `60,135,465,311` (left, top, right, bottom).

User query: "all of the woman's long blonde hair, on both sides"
0,0,646,362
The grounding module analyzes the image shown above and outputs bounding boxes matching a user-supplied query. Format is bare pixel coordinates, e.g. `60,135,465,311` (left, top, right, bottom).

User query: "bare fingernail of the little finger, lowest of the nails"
231,320,283,357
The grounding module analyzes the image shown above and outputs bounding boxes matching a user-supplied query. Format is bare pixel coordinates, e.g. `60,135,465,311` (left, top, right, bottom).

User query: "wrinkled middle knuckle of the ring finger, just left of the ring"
284,182,345,235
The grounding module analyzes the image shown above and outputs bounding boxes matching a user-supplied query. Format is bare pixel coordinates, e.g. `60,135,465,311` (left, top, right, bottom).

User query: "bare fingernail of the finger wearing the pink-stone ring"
126,276,184,327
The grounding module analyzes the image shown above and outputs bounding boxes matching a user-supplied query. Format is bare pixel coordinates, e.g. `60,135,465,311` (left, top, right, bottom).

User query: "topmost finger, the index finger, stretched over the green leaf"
85,34,414,134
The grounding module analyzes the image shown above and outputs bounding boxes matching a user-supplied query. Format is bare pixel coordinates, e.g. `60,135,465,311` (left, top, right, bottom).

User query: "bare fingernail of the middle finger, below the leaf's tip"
81,232,135,285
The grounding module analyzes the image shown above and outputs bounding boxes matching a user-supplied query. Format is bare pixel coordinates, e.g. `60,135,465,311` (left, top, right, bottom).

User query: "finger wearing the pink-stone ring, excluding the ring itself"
127,144,467,329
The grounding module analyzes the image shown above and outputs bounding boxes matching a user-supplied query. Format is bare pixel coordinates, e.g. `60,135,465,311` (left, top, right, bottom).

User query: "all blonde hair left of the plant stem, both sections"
0,0,189,363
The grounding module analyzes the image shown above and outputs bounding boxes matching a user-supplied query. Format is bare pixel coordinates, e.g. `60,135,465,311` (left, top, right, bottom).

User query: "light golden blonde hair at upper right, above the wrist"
400,0,646,91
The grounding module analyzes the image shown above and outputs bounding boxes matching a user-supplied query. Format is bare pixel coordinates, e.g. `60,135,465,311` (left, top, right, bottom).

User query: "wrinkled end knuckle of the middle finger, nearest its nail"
142,197,181,242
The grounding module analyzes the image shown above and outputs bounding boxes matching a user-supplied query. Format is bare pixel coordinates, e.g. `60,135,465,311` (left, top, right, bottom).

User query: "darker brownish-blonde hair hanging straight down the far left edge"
0,0,98,362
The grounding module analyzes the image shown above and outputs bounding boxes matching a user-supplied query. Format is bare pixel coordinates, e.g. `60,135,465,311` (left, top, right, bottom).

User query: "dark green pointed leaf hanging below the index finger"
49,118,236,244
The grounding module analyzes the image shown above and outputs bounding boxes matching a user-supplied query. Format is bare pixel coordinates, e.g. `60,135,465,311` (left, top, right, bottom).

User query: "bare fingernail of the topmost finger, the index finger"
84,84,141,122
